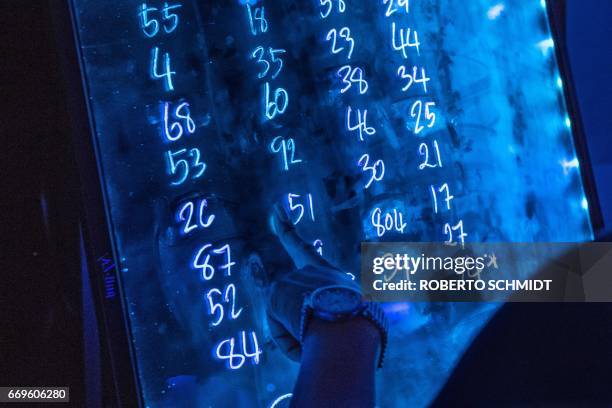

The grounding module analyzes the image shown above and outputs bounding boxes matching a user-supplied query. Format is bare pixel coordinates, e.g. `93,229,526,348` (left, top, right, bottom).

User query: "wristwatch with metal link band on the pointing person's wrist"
300,285,389,368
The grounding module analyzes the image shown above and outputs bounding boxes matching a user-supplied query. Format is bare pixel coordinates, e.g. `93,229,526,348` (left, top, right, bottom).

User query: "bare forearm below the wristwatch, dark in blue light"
292,318,380,408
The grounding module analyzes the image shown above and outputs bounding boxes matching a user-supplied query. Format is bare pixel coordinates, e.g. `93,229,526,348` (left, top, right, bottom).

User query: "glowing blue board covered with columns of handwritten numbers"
73,0,591,406
